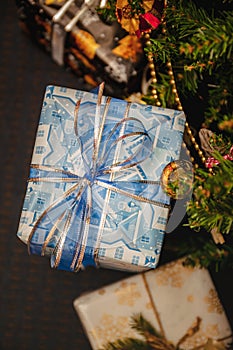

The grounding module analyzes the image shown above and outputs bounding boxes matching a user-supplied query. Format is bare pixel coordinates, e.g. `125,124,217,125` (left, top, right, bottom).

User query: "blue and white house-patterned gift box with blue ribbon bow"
17,86,185,271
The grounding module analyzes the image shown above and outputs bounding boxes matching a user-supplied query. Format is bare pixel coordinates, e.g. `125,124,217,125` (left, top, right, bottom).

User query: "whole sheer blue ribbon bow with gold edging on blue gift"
28,83,169,271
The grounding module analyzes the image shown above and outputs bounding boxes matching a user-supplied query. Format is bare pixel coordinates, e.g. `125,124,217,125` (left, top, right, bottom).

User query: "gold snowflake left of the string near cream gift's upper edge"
114,281,142,306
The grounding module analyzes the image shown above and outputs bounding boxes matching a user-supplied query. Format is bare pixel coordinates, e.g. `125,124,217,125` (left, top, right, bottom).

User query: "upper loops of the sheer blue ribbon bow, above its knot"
74,83,153,178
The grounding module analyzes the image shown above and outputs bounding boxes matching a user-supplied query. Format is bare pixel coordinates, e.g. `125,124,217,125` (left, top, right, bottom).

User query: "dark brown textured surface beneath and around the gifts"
0,0,233,350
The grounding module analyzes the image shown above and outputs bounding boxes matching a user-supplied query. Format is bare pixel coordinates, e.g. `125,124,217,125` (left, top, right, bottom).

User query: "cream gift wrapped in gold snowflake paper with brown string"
74,260,232,350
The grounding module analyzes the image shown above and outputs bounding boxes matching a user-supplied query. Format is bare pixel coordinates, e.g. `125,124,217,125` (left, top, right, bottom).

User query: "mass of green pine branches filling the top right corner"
145,0,233,134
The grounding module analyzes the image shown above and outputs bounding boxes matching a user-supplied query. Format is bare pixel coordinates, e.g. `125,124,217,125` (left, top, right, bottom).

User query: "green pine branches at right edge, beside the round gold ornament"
183,152,233,269
